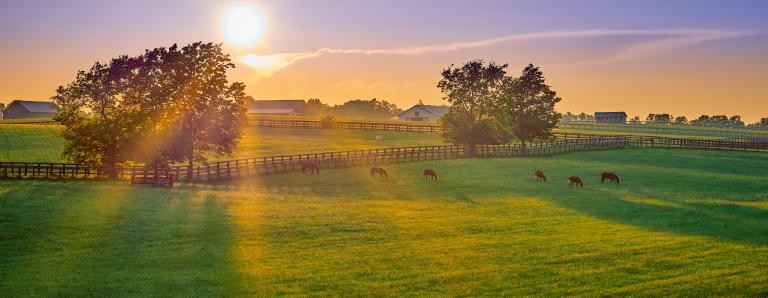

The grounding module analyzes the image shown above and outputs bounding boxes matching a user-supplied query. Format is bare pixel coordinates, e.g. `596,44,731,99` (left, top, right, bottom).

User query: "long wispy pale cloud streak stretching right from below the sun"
239,29,754,77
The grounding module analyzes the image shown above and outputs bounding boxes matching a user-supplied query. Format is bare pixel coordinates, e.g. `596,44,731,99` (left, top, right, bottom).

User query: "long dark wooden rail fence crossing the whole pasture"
0,134,768,182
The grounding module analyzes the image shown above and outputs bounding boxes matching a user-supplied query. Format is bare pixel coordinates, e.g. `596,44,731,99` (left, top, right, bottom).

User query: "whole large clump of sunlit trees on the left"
53,42,247,175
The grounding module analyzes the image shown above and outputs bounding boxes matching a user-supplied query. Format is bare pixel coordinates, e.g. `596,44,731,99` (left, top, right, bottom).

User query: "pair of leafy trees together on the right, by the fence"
438,60,560,145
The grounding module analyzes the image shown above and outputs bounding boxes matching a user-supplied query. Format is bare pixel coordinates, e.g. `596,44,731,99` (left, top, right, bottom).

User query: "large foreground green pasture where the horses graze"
0,149,768,297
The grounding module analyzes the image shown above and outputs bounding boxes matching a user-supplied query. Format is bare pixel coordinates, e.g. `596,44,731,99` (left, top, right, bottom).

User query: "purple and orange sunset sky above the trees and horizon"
0,0,768,122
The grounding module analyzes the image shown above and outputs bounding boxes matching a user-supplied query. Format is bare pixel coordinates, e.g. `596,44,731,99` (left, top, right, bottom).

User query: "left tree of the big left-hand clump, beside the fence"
52,56,145,175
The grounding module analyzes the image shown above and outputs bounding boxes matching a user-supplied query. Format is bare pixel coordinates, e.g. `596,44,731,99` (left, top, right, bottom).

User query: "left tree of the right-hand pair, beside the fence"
437,60,509,150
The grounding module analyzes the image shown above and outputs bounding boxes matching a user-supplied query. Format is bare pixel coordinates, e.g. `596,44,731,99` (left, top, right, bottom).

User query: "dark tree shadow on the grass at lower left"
0,182,242,296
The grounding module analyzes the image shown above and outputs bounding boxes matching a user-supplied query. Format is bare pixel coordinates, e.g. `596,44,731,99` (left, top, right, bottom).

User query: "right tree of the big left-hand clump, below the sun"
146,42,248,178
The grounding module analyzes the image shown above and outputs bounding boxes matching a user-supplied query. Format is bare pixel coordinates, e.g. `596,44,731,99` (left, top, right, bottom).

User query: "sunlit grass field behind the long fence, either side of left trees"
0,124,443,162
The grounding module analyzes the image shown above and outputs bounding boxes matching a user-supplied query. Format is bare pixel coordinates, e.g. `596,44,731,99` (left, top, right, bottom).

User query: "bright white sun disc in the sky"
221,4,264,46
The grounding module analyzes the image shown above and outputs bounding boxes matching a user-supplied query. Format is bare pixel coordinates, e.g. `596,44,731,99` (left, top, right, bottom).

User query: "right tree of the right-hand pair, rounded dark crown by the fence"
499,64,562,145
